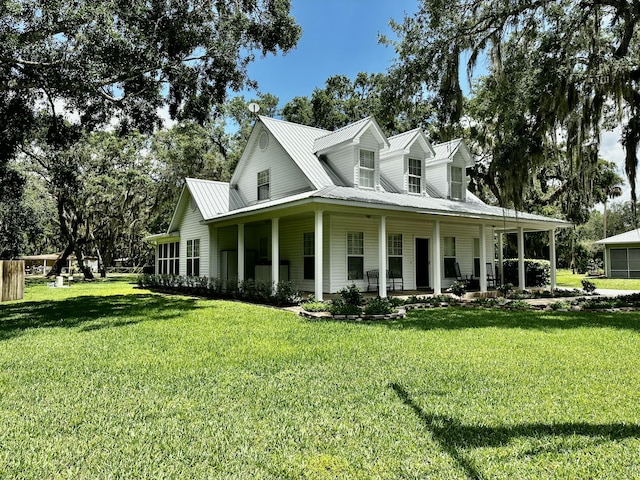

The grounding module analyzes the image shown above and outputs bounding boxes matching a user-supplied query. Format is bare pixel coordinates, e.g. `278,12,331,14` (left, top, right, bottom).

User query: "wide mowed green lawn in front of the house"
0,280,640,479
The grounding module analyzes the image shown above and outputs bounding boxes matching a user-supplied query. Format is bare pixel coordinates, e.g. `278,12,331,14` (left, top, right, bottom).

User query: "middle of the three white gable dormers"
380,128,435,195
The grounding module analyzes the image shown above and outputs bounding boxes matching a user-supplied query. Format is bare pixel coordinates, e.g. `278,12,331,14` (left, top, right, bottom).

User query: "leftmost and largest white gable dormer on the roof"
313,117,389,190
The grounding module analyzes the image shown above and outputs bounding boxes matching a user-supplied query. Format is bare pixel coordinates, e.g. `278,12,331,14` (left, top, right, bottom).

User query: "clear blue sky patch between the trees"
245,0,418,107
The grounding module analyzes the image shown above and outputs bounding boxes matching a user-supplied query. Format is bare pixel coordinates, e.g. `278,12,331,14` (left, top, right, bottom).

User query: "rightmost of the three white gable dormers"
426,138,474,201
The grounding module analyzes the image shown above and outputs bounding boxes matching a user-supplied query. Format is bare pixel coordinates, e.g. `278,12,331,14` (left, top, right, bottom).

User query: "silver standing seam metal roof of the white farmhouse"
158,117,572,235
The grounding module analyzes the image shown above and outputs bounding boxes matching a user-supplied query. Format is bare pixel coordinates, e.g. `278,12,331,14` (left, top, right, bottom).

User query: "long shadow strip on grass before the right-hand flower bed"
366,307,640,332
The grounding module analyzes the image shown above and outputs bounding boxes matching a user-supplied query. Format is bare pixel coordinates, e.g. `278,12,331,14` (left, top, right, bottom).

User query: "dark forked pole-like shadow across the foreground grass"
389,383,640,479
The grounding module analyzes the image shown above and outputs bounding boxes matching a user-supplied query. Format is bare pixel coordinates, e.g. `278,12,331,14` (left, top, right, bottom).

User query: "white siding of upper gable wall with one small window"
238,125,311,205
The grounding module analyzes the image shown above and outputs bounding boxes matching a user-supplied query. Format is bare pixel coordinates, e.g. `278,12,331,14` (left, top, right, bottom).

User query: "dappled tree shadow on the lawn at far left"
0,294,198,340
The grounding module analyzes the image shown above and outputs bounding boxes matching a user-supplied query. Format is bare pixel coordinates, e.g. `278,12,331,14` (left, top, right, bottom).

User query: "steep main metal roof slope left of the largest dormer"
260,117,333,188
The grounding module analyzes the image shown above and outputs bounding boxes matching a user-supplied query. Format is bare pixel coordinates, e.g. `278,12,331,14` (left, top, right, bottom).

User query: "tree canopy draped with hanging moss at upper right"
390,0,640,207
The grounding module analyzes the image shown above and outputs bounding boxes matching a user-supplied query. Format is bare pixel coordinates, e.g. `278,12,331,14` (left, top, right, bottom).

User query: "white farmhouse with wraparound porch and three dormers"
147,117,570,299
